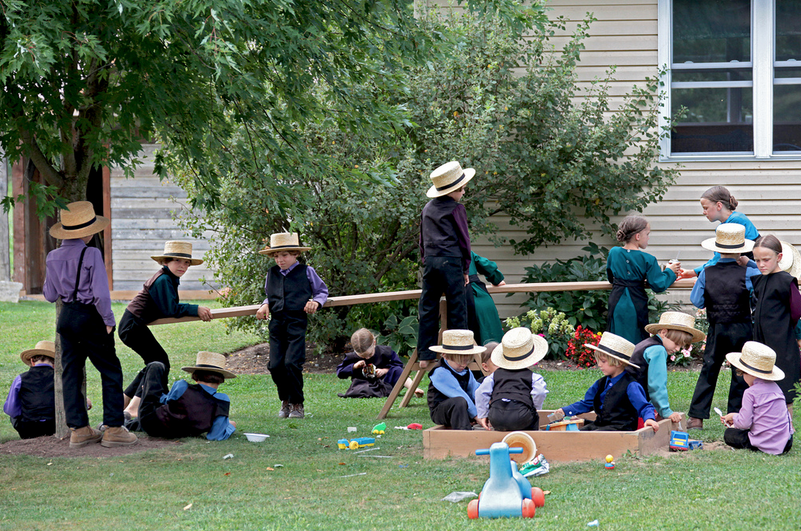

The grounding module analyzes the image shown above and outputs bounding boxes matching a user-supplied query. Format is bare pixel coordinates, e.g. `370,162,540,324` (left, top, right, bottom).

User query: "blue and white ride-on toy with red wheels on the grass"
467,442,544,519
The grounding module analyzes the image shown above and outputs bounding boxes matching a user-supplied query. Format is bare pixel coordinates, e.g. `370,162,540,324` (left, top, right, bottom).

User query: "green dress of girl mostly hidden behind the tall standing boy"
467,252,503,345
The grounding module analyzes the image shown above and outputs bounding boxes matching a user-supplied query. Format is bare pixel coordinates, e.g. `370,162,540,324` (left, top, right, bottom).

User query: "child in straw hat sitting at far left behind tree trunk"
3,341,56,439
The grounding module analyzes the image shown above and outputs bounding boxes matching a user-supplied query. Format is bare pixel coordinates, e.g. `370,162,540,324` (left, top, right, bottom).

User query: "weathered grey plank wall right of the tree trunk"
110,144,213,292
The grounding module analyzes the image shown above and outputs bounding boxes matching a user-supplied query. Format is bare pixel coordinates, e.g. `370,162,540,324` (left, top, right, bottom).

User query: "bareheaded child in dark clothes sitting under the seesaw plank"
337,328,423,398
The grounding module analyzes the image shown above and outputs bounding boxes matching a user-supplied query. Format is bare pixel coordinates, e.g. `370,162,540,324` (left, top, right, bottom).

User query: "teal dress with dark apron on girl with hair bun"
606,247,676,345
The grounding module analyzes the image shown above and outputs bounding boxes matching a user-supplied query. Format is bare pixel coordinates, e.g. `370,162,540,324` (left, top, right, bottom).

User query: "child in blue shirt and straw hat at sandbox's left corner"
428,330,484,430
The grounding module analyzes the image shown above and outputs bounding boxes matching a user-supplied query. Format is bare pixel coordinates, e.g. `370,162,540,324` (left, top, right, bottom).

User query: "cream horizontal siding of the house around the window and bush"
424,0,801,317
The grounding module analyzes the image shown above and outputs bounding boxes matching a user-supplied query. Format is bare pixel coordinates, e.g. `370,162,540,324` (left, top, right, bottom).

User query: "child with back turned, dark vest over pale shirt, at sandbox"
476,328,548,431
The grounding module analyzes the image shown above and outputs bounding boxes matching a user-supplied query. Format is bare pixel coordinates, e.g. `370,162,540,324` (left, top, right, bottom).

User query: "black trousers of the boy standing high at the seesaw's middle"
417,256,469,360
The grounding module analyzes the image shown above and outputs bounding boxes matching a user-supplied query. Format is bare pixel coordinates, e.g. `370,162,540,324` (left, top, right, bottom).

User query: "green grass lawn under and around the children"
0,302,801,531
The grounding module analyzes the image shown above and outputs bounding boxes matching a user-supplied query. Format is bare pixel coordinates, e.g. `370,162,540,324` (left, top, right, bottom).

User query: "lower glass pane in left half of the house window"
670,88,754,153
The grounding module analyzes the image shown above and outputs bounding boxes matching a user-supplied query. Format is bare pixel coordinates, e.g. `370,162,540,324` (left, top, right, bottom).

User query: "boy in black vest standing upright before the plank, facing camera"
256,232,328,419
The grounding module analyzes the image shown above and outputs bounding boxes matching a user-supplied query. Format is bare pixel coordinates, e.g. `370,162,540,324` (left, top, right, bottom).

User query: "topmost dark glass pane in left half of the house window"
673,0,751,63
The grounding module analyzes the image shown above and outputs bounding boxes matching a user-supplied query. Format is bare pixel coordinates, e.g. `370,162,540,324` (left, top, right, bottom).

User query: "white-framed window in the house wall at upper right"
659,0,801,158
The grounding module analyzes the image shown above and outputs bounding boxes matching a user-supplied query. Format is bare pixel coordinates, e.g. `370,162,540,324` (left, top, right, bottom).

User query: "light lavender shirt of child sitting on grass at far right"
732,378,794,455
